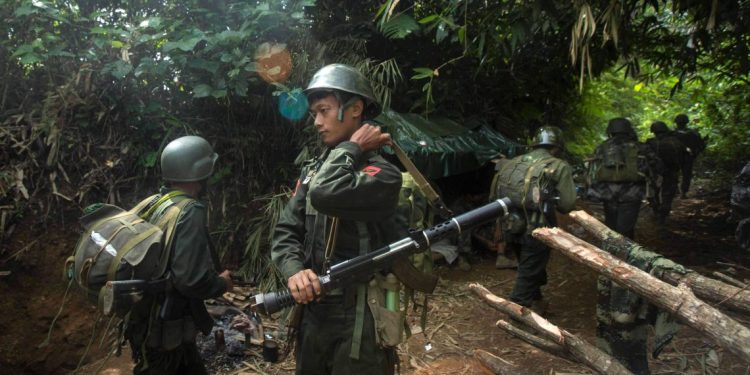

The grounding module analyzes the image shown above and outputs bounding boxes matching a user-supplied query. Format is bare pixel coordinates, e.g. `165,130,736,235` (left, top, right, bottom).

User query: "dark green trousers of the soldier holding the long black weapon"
296,296,395,375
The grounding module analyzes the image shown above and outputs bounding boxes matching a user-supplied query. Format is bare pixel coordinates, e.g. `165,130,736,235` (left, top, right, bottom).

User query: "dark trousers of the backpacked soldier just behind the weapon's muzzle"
507,234,550,307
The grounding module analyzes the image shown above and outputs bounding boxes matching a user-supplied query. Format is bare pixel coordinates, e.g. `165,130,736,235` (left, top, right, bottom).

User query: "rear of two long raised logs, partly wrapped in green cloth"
570,211,750,314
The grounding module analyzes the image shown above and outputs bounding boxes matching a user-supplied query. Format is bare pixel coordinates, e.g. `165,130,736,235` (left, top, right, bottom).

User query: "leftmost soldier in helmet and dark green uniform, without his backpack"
125,136,233,374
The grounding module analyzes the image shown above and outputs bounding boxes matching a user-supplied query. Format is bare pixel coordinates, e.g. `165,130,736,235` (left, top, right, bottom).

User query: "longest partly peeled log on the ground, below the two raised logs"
469,283,632,375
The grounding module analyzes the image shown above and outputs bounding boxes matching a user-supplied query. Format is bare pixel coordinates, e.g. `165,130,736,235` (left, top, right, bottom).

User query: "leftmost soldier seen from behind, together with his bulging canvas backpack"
65,136,233,374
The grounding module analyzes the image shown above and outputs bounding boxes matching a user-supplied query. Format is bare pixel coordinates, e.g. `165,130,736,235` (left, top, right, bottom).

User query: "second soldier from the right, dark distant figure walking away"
646,121,687,224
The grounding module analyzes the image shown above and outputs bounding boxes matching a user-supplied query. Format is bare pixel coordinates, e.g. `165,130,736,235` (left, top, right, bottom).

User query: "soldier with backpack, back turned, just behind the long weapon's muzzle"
491,126,576,313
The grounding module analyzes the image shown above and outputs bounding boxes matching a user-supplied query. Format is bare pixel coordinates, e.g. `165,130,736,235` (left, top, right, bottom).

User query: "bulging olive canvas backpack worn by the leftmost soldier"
64,191,193,317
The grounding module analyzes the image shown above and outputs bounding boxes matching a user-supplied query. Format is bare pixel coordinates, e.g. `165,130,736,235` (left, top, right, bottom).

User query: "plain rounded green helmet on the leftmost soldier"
161,135,219,182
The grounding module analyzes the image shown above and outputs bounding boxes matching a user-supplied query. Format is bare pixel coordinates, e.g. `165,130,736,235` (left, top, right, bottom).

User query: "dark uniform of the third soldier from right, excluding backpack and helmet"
587,133,662,239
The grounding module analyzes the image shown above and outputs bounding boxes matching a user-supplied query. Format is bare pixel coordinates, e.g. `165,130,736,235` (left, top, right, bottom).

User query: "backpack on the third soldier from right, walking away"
589,140,644,183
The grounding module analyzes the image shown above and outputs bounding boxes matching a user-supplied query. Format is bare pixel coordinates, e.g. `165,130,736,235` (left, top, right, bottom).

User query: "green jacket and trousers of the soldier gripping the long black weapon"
271,141,401,374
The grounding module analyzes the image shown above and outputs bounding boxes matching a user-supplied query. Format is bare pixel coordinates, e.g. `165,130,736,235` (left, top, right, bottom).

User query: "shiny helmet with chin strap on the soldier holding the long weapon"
303,64,378,121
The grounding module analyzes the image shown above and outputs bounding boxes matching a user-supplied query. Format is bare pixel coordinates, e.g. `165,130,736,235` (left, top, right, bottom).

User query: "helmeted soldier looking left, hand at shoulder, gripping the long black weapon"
271,64,401,374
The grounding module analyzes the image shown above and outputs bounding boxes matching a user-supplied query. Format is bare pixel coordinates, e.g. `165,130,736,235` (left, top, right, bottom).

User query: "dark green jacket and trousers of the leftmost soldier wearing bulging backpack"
125,188,227,374
